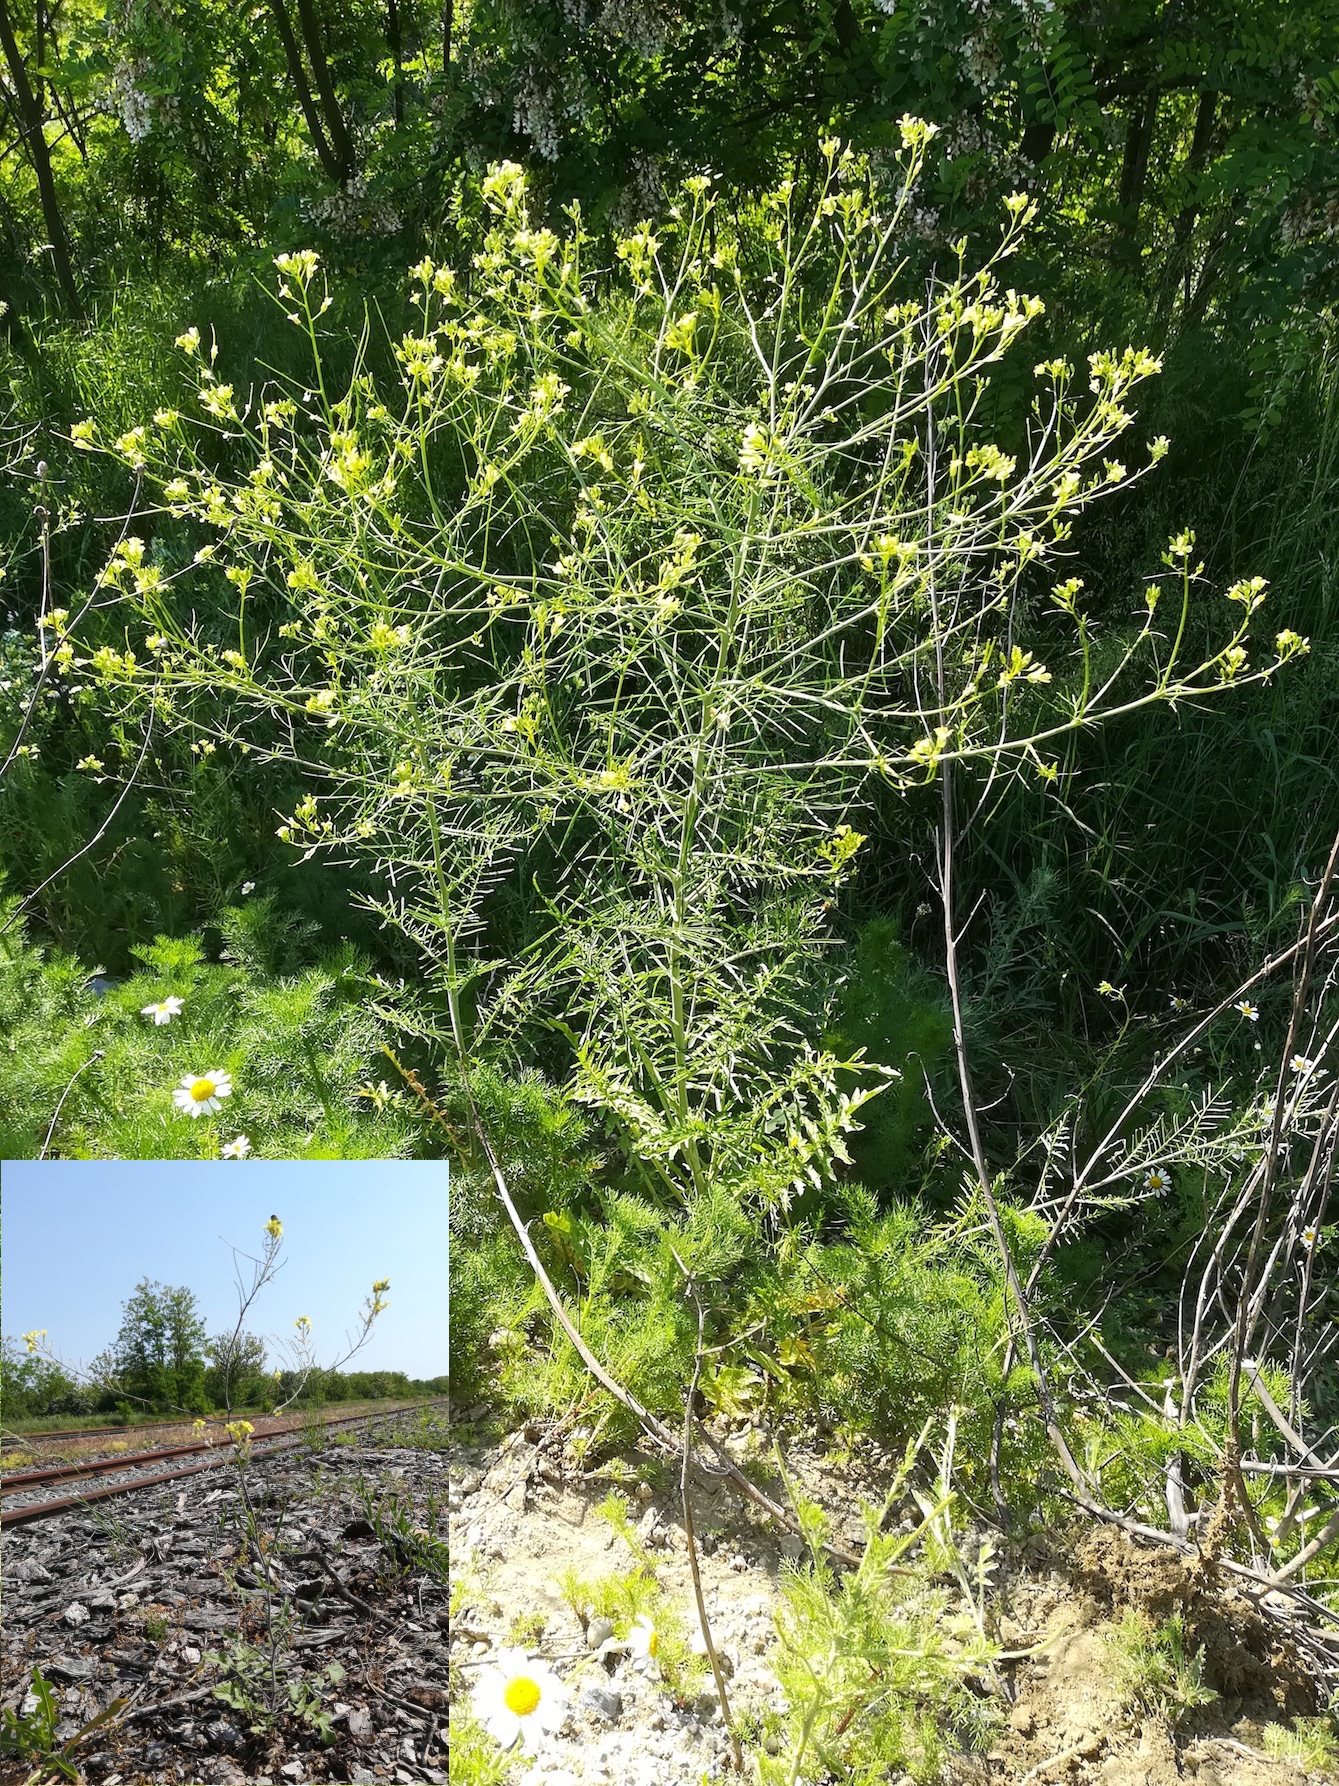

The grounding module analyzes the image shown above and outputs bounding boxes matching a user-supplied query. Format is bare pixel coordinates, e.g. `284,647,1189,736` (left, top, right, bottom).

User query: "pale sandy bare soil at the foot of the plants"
448,1418,1339,1786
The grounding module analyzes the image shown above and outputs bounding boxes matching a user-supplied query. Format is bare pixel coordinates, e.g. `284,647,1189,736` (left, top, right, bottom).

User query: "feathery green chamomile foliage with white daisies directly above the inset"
0,902,421,1159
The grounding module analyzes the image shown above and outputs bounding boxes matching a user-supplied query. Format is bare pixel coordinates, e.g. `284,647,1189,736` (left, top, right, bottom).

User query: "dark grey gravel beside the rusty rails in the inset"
0,1427,446,1786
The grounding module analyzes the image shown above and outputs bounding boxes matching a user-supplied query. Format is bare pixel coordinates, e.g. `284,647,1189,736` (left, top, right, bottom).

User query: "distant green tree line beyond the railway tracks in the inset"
0,1279,446,1422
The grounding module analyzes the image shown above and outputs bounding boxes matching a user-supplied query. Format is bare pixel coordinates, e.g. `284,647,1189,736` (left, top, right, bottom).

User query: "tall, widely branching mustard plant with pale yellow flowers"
68,120,1305,1213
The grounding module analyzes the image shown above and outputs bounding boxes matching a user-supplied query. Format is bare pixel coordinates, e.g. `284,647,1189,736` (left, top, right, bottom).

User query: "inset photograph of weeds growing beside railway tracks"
0,1161,446,1786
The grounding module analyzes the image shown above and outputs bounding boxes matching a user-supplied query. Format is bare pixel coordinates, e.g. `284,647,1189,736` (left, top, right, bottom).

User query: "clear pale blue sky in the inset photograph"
0,1159,446,1377
